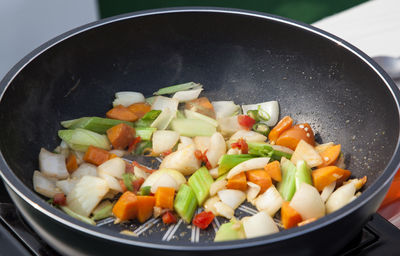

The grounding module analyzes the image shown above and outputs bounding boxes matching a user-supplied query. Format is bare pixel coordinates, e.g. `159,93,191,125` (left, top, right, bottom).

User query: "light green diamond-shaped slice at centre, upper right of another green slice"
188,166,214,205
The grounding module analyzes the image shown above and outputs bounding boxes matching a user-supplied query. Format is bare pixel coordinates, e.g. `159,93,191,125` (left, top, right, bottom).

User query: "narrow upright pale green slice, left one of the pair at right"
278,158,296,201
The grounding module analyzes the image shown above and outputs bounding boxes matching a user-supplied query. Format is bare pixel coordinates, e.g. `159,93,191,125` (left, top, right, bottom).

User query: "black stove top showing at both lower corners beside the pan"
0,183,400,256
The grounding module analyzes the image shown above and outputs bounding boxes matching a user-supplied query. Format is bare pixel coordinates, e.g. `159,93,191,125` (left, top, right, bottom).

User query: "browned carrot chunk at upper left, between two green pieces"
107,123,136,149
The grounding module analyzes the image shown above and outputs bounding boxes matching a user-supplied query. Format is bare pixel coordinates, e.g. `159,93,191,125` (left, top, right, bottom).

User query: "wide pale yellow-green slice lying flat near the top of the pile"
171,118,217,137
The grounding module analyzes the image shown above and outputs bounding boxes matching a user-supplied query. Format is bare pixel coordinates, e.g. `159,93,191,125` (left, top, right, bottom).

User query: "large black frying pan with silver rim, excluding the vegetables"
0,8,400,255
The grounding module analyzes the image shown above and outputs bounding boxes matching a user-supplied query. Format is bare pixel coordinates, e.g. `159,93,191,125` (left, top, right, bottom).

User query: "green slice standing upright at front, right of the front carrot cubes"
174,184,197,223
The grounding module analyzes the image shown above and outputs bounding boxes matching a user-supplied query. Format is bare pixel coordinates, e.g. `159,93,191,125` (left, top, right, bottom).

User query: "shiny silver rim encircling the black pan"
0,7,400,251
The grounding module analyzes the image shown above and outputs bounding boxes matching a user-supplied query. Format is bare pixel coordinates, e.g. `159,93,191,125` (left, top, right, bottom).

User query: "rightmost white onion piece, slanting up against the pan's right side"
326,182,356,213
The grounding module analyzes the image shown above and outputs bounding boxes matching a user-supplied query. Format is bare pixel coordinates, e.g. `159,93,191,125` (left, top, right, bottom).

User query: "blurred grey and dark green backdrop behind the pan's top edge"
0,0,366,79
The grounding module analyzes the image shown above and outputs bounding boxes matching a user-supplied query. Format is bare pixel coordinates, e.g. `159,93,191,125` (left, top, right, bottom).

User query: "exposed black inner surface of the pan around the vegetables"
0,12,399,243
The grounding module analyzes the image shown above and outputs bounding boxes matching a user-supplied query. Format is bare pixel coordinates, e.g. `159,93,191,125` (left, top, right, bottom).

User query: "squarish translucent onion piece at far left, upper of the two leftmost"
39,148,69,179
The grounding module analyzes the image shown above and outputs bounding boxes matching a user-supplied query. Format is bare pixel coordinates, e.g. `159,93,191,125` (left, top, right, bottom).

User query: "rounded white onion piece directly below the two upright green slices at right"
289,183,325,220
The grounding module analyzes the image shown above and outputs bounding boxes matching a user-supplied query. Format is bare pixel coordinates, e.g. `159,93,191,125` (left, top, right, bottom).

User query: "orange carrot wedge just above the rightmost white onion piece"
312,166,351,191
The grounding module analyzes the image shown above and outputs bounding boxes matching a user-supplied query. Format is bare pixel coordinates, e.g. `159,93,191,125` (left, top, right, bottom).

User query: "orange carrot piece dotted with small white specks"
276,123,315,150
